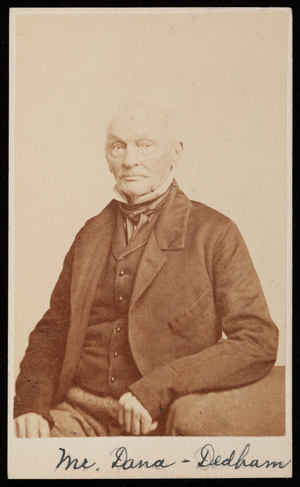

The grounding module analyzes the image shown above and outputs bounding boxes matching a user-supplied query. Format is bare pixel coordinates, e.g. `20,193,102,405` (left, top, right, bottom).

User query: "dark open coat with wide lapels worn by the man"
15,182,278,424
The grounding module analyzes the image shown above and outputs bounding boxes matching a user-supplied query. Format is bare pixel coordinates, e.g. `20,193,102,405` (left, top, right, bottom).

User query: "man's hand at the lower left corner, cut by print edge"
15,413,50,438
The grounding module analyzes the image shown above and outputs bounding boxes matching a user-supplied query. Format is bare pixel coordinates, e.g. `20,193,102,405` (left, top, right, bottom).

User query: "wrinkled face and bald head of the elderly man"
106,110,181,203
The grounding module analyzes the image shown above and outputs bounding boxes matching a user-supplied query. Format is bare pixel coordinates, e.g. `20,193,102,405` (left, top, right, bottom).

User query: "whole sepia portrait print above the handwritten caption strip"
10,9,290,478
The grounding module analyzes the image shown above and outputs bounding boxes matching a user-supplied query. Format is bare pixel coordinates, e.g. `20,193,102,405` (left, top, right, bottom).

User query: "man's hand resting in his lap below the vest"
119,392,158,436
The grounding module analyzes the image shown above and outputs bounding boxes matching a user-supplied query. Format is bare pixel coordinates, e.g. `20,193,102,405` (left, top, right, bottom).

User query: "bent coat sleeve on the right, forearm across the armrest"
130,221,278,419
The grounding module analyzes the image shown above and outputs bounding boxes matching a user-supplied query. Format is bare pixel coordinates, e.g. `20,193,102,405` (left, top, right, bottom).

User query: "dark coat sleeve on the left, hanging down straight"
14,244,75,425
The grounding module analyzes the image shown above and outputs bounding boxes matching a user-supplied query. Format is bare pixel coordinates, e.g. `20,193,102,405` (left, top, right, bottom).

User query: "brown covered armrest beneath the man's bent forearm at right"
165,367,285,436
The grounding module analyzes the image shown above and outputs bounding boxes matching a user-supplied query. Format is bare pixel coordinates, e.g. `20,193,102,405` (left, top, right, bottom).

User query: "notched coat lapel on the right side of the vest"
129,180,192,312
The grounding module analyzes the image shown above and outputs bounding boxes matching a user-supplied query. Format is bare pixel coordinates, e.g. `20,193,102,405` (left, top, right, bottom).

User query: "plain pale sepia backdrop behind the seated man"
11,9,288,380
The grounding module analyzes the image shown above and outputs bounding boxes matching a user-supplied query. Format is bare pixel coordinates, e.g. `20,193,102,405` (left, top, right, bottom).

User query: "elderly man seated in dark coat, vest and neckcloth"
15,106,278,437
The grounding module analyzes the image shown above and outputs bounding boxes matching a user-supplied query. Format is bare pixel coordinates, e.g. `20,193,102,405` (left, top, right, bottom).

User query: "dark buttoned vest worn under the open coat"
73,212,158,399
